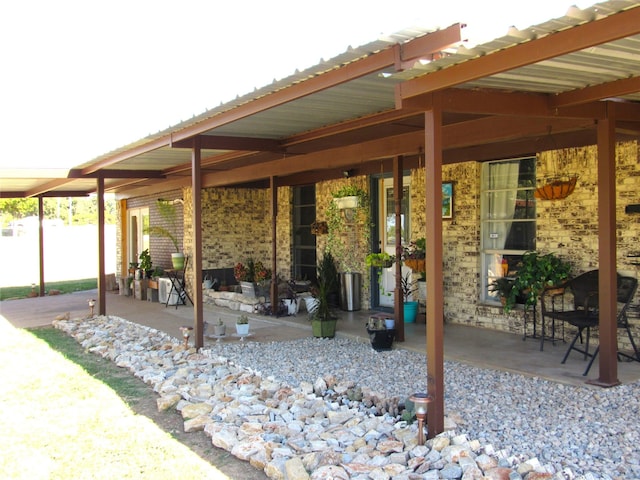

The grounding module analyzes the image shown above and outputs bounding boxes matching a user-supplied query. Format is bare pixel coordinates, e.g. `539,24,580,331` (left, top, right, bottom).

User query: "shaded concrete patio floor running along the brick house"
0,290,640,388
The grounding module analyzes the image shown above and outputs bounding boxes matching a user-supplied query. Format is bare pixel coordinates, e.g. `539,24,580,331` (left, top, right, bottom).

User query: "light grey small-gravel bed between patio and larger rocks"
210,337,640,479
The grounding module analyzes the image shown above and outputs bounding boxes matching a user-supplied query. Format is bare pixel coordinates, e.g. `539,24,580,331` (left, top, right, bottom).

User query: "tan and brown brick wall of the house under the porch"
118,142,640,345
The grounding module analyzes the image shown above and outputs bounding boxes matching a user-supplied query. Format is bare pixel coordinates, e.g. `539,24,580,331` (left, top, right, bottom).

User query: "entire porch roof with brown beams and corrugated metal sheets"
0,0,640,197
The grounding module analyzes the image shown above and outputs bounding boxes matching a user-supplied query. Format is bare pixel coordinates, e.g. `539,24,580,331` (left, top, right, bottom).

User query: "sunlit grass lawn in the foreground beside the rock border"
0,316,234,480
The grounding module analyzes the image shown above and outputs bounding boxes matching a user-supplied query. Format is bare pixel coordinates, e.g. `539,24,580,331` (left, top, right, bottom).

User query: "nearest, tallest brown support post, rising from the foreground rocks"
425,97,444,438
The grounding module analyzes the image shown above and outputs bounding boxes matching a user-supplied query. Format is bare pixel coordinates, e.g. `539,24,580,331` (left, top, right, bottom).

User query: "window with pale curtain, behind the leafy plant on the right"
480,158,536,302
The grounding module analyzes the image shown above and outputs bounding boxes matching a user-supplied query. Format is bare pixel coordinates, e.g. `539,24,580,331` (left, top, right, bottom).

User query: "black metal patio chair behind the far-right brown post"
541,270,640,375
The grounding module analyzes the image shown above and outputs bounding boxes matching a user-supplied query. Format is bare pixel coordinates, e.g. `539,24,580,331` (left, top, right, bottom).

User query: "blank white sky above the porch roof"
0,0,595,169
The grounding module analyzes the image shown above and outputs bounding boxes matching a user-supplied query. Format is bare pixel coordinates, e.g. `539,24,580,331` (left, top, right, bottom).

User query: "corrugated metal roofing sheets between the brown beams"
0,0,640,197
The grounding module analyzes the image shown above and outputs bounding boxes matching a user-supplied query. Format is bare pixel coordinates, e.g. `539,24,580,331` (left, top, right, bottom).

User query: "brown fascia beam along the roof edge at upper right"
396,7,640,102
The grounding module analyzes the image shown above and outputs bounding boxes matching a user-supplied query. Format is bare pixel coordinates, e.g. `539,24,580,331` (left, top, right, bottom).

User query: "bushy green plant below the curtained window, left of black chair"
504,252,571,312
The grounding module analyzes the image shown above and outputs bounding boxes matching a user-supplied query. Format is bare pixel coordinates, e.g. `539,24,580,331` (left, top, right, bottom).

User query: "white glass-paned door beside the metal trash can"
378,177,410,308
